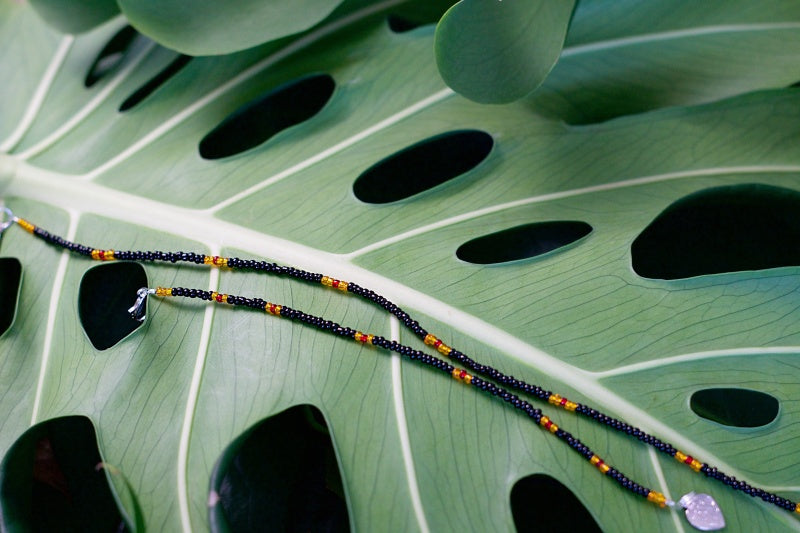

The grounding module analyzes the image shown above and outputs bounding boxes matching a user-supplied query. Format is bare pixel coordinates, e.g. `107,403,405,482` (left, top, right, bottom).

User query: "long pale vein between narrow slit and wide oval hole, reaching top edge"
80,0,406,180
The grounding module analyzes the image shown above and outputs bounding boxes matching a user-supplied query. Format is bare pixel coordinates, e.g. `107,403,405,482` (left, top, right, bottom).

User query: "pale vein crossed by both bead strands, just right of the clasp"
178,260,220,533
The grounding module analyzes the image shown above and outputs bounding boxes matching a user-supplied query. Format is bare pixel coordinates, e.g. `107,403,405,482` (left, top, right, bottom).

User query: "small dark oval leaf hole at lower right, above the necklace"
689,388,780,428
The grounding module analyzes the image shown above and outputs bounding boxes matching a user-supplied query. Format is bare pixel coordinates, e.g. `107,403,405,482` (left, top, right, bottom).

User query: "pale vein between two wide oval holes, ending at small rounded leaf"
204,89,455,214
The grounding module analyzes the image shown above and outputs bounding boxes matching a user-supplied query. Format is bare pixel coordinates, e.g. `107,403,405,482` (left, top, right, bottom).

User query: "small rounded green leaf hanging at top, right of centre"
435,0,575,104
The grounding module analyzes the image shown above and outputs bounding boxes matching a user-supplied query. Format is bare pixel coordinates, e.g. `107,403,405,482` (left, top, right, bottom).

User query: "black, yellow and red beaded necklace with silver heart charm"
0,208,800,531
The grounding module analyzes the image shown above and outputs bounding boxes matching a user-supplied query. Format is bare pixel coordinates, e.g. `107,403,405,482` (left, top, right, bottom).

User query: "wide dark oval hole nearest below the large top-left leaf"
199,74,336,159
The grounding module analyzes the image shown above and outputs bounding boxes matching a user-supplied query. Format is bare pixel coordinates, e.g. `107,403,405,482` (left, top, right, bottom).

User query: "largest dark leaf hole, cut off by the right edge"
631,184,800,279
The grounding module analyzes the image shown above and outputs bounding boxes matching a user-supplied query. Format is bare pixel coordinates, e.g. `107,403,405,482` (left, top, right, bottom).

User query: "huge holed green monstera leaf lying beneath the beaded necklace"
0,0,800,531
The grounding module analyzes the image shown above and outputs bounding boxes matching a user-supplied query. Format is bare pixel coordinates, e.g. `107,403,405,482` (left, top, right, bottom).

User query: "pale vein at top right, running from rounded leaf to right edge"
561,22,800,57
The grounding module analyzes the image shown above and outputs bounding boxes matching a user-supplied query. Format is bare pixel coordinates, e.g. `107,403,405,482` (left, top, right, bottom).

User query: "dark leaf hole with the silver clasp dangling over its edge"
78,262,147,350
